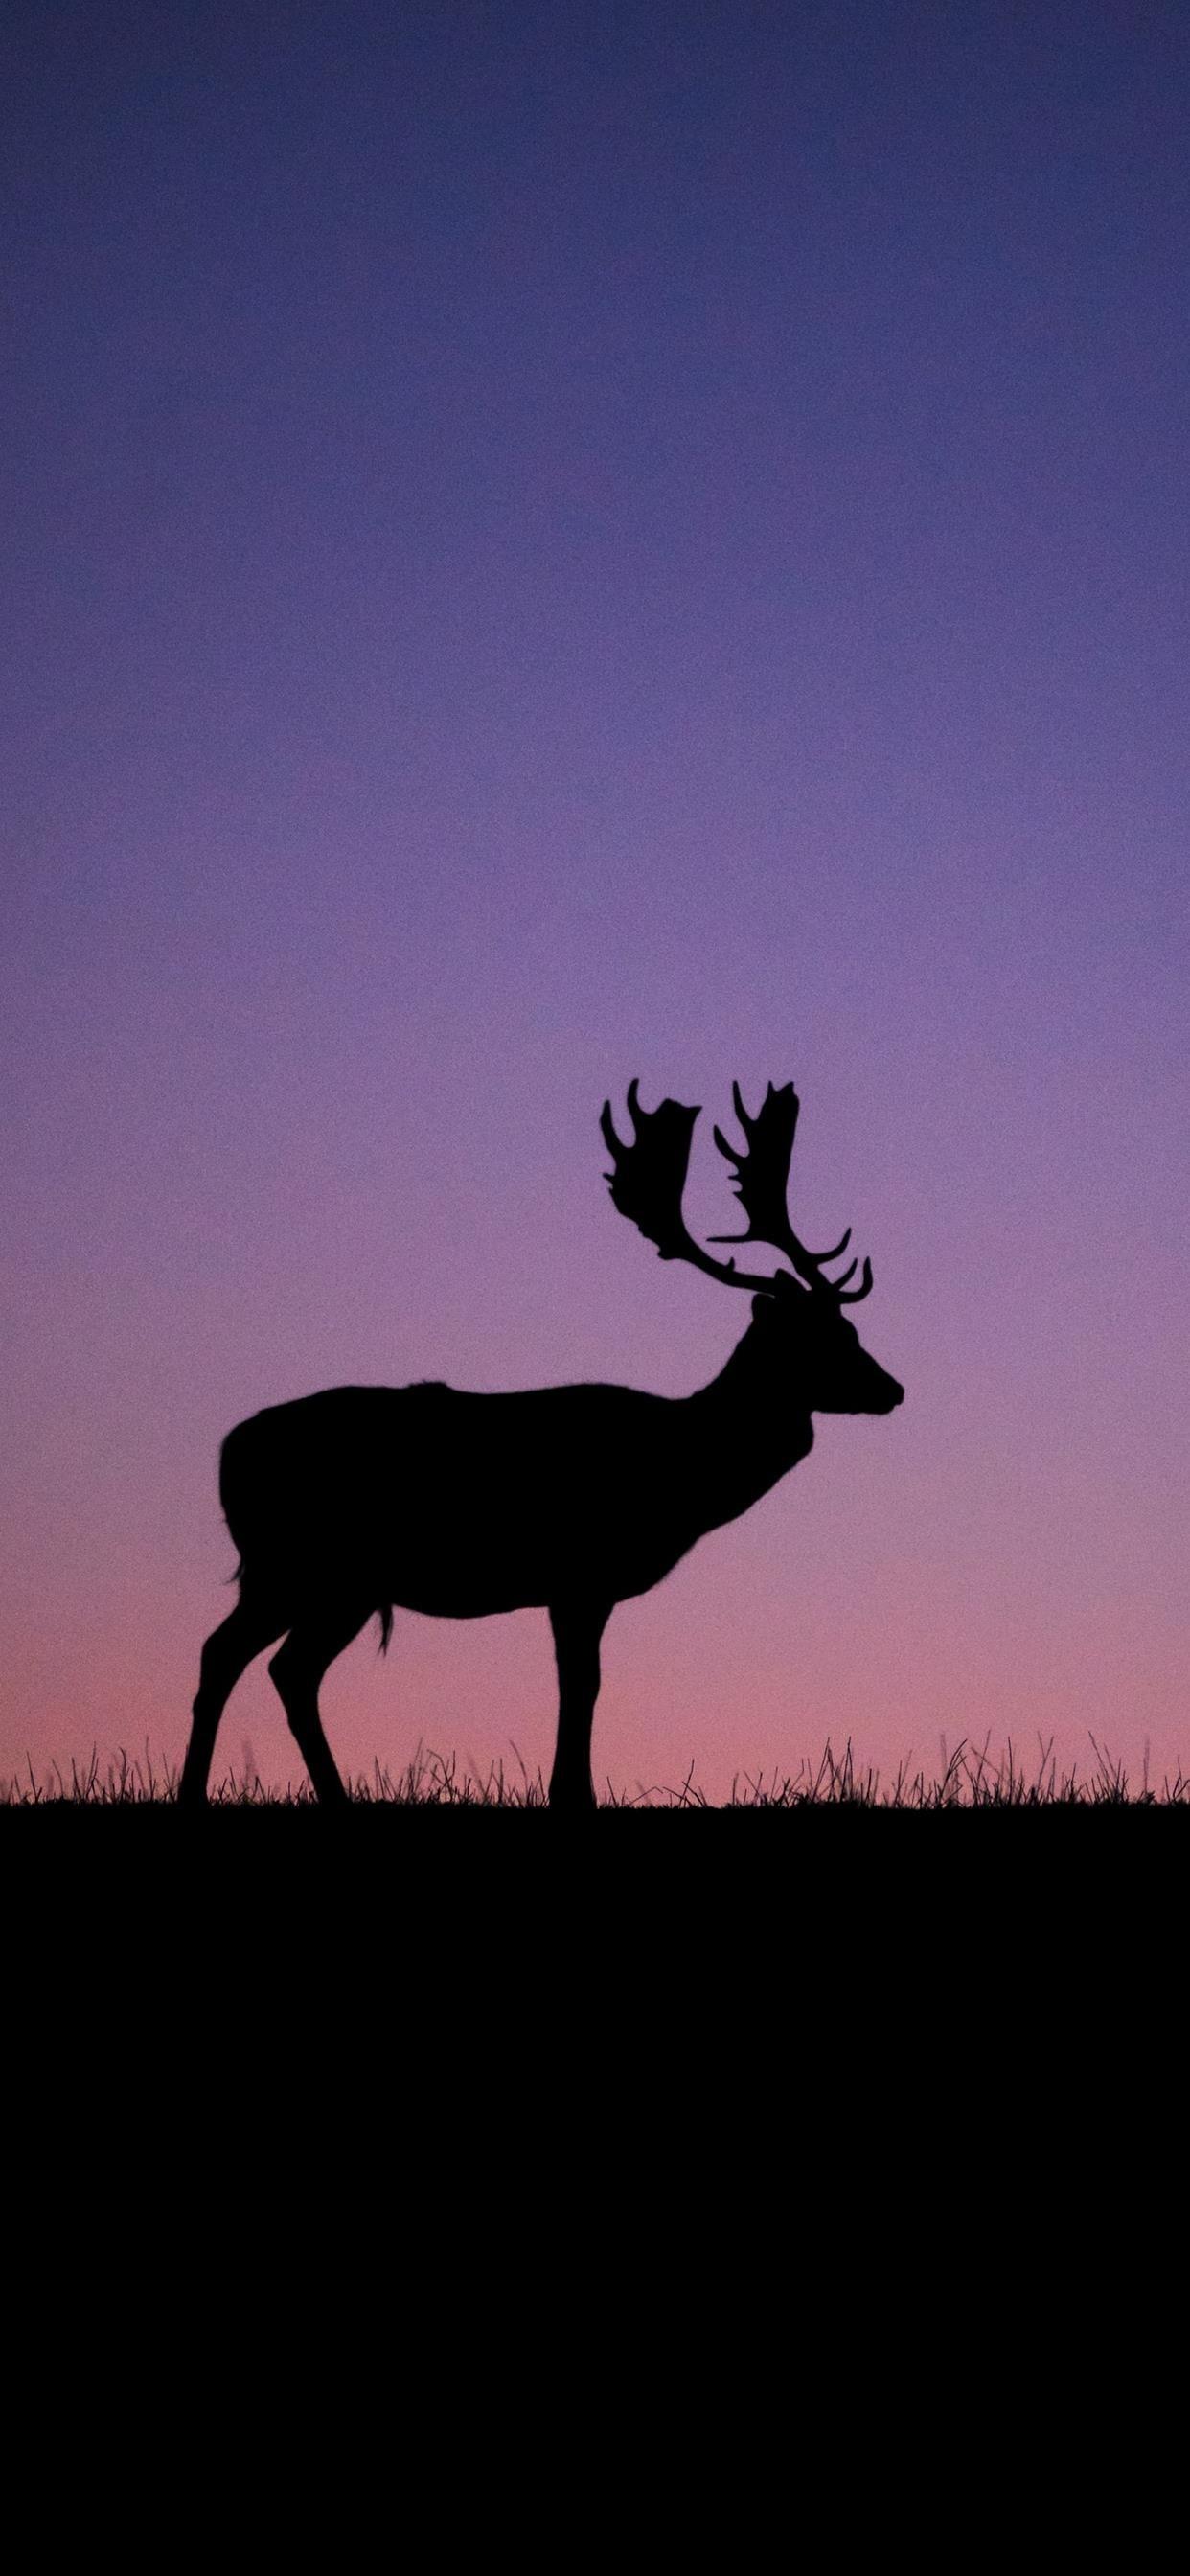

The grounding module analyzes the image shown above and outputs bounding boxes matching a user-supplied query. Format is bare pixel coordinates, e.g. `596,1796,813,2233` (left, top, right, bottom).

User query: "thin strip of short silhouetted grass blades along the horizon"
0,1736,1190,1813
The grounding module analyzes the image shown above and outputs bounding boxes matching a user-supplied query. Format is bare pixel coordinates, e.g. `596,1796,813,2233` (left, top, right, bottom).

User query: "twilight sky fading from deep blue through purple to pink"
0,0,1190,1796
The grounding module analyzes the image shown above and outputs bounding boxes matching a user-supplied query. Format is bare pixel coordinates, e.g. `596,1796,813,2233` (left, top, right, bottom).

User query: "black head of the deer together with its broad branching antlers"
600,1082,904,1414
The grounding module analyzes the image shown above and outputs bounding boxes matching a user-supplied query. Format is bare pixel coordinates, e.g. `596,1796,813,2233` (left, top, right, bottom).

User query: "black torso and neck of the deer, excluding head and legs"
219,1326,814,1618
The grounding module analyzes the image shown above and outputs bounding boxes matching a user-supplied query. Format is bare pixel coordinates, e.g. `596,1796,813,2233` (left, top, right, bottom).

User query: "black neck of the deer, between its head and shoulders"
685,1324,814,1528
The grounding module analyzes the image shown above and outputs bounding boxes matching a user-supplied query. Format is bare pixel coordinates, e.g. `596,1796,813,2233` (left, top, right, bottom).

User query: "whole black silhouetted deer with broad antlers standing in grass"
177,1082,904,1811
